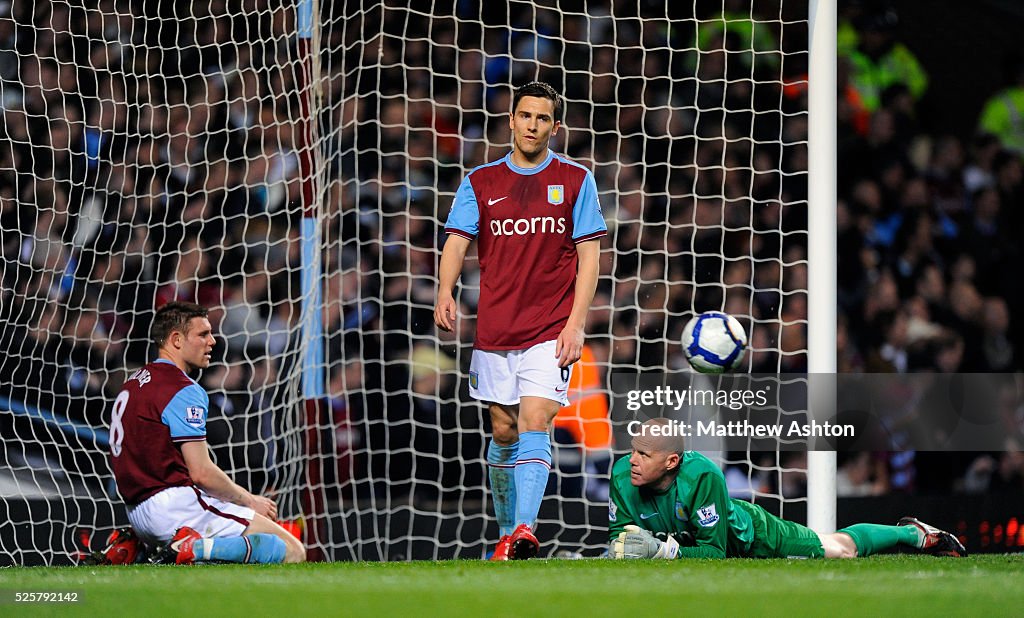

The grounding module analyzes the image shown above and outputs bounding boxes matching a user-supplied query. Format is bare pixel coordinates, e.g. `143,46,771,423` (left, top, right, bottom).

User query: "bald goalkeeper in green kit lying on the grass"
608,418,967,559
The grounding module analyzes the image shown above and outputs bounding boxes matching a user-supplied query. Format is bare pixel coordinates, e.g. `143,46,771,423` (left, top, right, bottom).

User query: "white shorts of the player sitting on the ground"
128,487,255,543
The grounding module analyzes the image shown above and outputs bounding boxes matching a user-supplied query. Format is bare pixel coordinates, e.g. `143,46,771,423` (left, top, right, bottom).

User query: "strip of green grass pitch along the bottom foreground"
0,555,1024,618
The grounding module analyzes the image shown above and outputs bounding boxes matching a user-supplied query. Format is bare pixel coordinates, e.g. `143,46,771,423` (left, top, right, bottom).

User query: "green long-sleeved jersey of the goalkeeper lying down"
608,451,762,558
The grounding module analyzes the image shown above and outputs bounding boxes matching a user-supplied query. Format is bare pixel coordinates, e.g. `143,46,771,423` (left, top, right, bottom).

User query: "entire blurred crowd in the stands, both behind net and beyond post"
0,0,1024,501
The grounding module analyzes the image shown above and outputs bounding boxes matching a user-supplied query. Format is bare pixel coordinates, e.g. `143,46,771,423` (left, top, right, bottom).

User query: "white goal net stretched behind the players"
0,0,807,564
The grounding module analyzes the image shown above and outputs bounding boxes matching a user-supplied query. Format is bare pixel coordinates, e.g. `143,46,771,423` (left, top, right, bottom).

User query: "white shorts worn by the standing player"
469,341,572,405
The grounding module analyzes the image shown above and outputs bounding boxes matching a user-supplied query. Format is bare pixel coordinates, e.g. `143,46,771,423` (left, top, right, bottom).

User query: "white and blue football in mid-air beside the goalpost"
683,311,746,373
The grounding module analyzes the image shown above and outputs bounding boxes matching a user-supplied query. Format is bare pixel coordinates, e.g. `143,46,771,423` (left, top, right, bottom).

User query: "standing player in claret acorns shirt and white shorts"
434,82,607,560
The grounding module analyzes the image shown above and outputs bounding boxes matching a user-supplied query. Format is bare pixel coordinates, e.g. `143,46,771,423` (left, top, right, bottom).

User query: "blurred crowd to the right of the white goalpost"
838,2,1024,495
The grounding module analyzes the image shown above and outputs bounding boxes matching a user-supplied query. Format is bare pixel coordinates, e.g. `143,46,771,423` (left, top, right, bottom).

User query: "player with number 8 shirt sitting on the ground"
111,302,305,564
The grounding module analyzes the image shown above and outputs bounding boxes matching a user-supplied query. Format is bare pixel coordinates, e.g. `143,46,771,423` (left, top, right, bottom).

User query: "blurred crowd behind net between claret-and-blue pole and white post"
329,2,807,498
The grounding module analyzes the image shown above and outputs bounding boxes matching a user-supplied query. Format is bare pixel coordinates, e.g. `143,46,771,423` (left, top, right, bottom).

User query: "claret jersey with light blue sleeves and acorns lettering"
444,150,608,350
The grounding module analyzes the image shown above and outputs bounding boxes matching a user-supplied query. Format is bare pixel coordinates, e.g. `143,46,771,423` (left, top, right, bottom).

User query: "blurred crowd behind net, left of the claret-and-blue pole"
0,0,315,489
